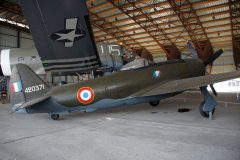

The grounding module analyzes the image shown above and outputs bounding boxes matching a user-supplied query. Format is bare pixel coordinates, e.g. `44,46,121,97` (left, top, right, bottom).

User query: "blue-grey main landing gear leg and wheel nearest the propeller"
199,86,217,119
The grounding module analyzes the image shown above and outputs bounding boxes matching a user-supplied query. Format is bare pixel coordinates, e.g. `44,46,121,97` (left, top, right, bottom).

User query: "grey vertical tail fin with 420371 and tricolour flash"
10,64,50,110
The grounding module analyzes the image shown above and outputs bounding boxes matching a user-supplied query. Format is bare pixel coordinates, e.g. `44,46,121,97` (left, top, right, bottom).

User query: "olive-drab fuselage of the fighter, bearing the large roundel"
51,59,205,107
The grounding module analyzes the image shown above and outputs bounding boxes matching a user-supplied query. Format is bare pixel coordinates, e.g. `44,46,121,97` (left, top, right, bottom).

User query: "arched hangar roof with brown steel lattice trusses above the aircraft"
0,0,240,73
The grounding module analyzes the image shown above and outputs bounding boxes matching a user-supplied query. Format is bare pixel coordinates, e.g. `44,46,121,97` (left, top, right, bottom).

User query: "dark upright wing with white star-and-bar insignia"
20,0,100,74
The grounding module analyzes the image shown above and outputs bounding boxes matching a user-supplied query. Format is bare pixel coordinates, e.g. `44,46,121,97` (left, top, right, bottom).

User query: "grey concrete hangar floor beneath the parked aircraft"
0,93,240,160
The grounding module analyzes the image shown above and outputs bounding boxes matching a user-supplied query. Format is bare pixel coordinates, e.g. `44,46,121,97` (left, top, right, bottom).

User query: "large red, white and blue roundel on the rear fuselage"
77,87,95,104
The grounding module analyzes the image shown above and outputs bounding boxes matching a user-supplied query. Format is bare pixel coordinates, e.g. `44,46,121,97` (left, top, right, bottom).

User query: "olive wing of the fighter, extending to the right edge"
132,71,240,97
